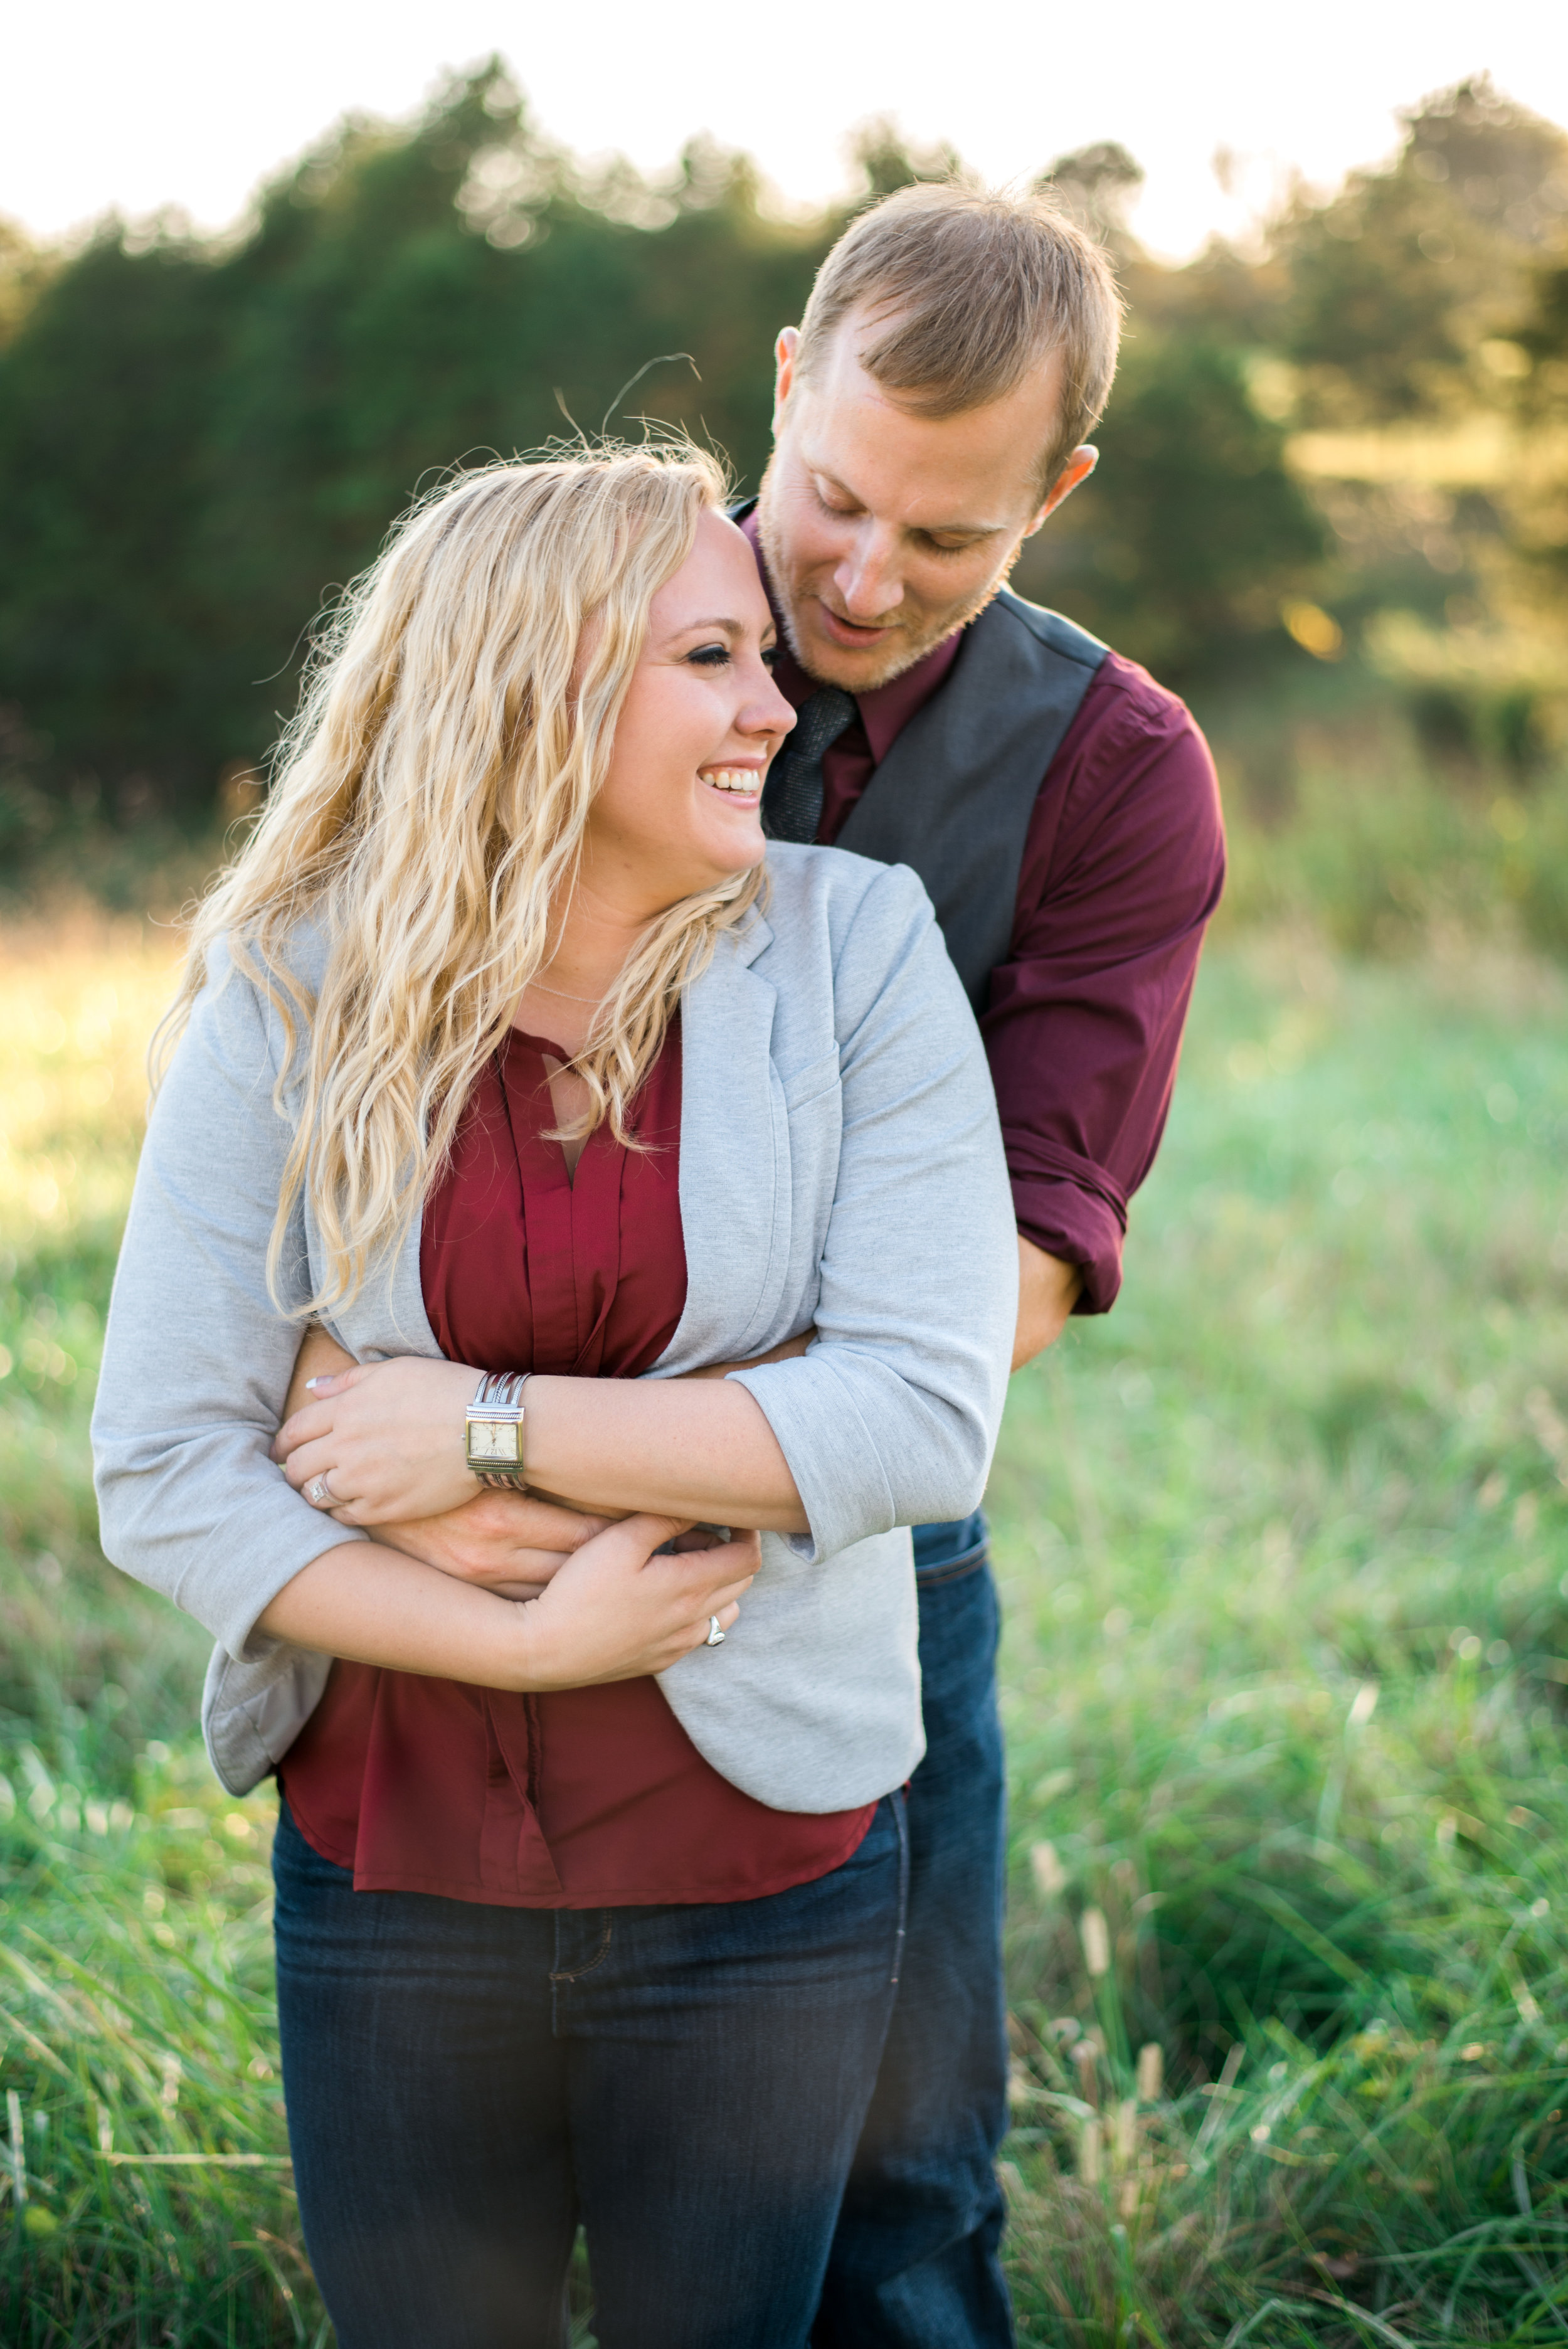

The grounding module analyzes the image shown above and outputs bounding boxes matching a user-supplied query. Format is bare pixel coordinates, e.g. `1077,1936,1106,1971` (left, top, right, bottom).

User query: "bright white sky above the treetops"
0,0,1568,256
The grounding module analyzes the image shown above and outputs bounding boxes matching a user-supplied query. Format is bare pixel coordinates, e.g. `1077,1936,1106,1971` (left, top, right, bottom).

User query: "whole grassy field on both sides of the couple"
0,923,1568,2349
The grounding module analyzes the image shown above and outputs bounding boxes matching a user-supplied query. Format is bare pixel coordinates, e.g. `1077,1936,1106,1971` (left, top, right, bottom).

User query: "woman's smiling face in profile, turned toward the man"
582,512,796,914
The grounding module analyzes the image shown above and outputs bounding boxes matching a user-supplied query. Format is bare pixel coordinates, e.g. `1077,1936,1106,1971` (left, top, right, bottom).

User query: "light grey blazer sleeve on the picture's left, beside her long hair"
92,949,366,1661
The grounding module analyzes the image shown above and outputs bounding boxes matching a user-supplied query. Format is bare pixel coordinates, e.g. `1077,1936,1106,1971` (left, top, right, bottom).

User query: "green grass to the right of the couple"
995,946,1568,2349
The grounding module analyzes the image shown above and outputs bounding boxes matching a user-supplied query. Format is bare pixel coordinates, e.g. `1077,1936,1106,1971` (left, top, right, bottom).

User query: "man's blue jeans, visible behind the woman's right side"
812,1515,1014,2349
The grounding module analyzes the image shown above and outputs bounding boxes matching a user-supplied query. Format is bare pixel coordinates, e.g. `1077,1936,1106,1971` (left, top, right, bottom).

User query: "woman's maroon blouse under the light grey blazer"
279,1022,876,1907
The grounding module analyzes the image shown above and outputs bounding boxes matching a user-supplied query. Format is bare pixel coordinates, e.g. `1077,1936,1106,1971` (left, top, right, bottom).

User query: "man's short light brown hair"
796,181,1122,489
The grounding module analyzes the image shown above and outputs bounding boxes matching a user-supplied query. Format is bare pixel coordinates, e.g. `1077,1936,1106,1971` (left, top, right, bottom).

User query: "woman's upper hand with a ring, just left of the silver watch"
272,1355,481,1525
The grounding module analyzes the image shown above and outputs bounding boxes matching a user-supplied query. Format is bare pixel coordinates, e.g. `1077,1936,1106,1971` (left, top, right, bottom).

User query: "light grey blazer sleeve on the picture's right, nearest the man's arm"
733,864,1019,1564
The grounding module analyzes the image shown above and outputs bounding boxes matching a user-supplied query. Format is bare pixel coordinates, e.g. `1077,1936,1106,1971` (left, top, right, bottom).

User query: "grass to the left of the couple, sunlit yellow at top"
0,918,329,2349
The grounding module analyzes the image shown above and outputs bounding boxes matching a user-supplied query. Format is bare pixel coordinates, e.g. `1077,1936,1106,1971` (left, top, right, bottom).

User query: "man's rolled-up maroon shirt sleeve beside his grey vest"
981,653,1226,1313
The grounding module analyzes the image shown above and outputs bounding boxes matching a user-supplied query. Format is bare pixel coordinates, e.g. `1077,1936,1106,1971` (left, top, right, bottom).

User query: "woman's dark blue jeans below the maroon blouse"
272,1795,908,2349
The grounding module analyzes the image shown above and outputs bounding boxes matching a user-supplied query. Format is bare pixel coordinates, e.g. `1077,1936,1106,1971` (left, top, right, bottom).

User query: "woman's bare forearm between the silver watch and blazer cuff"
524,1377,810,1534
